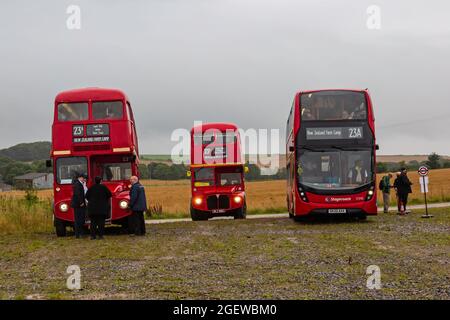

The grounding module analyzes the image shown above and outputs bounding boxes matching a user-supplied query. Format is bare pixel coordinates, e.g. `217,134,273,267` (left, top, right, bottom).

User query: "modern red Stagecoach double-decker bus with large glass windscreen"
286,89,378,220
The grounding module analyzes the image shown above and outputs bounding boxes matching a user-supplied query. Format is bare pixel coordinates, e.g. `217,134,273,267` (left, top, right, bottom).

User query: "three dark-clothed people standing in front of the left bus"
71,174,147,240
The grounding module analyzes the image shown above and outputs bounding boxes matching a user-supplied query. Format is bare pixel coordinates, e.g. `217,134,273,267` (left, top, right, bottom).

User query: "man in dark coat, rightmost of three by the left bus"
129,176,147,236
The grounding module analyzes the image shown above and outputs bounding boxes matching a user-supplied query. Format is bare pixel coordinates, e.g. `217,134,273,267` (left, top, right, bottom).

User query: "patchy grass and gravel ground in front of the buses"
0,209,450,299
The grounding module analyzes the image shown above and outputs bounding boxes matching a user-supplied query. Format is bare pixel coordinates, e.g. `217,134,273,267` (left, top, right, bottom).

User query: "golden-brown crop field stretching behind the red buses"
0,169,450,217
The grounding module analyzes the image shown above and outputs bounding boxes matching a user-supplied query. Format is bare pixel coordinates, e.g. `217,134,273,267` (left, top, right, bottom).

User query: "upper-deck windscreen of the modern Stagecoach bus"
300,90,367,121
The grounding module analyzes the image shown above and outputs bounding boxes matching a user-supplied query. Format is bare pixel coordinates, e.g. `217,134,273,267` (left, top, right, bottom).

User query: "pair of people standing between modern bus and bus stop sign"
379,168,412,215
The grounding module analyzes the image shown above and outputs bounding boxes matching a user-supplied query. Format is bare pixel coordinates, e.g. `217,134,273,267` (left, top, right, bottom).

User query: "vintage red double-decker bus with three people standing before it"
49,88,139,236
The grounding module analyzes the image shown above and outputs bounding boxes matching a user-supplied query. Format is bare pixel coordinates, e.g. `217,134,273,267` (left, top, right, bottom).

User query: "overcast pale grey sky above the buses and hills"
0,0,450,154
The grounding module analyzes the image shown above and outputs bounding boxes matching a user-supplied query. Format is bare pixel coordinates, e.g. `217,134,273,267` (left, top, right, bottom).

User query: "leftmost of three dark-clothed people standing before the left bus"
70,174,86,239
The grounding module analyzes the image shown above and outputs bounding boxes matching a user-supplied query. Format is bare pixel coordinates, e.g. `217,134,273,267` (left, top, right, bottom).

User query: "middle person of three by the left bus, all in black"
86,177,112,240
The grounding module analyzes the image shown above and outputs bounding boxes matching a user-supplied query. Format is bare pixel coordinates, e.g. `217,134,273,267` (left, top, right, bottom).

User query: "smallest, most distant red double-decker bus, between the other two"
188,123,247,221
